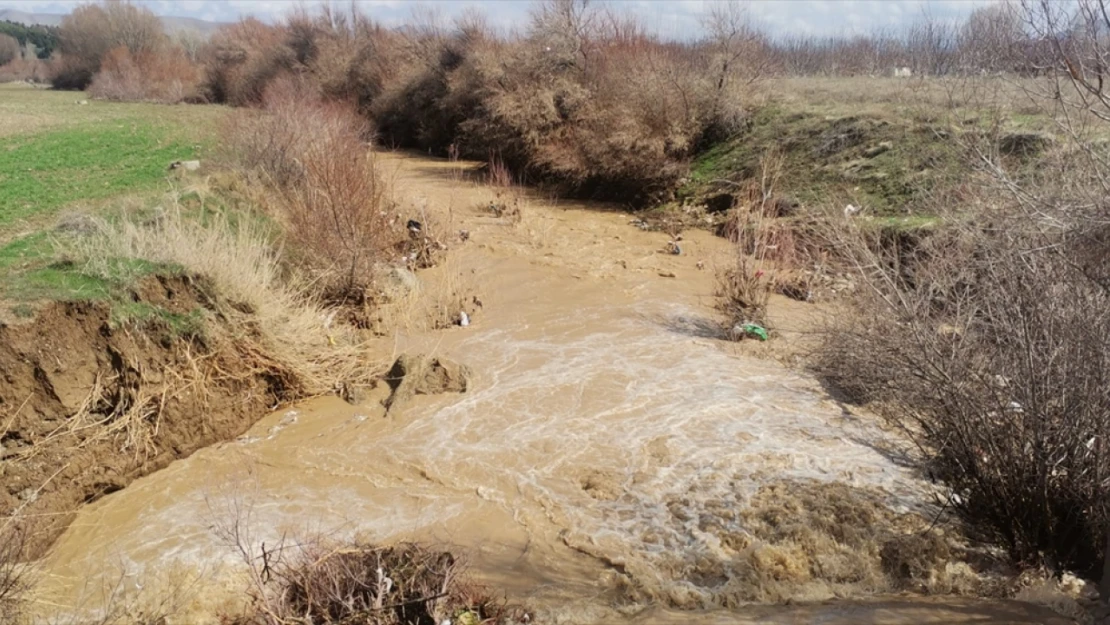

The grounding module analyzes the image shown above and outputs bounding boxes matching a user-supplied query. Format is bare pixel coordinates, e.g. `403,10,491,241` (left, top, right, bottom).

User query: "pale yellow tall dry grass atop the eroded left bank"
73,190,384,394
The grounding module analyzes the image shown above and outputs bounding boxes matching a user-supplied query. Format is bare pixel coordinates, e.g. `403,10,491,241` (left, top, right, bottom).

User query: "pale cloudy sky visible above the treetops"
0,0,990,38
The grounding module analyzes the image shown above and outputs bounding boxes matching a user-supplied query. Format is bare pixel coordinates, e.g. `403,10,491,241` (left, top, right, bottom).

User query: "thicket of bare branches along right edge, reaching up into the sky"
818,0,1110,596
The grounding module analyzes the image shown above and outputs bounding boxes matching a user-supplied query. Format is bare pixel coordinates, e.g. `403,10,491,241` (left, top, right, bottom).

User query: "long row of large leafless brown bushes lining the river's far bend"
195,0,764,208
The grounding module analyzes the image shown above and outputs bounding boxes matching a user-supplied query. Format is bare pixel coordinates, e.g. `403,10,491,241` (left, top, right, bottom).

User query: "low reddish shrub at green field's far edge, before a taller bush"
89,47,200,103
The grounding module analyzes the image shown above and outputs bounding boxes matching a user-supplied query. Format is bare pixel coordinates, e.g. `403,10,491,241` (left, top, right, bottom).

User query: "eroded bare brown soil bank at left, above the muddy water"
0,276,281,557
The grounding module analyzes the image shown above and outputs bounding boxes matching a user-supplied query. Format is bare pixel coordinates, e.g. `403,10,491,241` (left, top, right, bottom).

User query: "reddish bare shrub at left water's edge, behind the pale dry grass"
222,80,396,305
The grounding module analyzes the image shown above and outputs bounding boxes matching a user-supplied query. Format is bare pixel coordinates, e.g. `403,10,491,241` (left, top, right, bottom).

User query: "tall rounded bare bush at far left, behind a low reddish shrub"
52,0,167,89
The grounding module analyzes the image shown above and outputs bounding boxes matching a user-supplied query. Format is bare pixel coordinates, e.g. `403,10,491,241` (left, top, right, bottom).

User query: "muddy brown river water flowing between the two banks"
32,154,1068,624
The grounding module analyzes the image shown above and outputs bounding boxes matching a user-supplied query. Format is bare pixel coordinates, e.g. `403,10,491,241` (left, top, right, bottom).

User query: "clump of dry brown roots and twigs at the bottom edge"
233,541,529,625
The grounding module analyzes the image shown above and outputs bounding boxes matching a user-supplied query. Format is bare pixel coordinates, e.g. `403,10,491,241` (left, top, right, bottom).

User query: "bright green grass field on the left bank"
0,84,226,327
